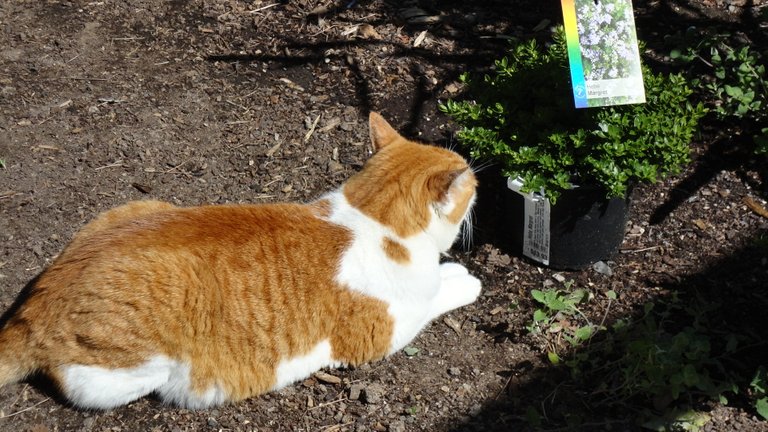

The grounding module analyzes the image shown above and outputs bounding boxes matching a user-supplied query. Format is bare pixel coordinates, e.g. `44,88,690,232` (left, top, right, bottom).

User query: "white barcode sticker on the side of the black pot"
507,178,549,265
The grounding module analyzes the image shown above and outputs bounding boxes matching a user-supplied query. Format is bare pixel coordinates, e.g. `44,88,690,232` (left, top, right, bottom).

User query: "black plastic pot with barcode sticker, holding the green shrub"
509,179,630,270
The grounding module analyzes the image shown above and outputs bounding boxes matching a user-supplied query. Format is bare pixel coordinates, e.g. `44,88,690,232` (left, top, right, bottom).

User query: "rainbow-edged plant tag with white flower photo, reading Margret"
561,0,645,108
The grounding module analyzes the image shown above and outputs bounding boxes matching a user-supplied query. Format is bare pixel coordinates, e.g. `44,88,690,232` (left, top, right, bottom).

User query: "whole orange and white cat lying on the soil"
0,113,480,409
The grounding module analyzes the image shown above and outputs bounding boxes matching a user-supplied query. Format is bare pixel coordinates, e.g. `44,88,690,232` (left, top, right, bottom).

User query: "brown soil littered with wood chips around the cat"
0,0,768,432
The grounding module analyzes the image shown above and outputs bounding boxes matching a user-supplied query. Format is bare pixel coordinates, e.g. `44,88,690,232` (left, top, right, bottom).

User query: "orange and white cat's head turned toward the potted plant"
343,113,477,251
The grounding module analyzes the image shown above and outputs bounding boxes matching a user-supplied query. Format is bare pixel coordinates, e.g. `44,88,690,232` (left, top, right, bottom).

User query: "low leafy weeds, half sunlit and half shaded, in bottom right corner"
528,281,768,431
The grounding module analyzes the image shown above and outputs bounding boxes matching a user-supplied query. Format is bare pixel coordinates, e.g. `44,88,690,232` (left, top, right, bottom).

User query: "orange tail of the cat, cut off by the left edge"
0,323,36,387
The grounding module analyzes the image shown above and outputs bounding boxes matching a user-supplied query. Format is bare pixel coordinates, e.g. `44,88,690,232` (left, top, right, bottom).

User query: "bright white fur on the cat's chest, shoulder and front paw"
326,192,480,354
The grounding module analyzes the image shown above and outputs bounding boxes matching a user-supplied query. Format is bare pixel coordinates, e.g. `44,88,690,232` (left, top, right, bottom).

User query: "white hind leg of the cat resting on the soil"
52,356,177,409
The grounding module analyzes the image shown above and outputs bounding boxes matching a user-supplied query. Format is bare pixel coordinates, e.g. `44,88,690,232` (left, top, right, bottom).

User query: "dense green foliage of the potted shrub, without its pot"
440,30,704,202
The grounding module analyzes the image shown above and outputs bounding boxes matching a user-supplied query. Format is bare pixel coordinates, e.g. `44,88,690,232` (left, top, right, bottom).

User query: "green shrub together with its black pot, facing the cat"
440,30,704,268
